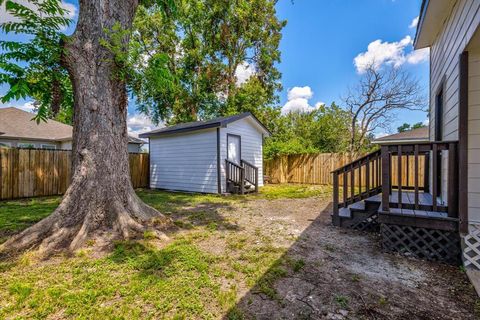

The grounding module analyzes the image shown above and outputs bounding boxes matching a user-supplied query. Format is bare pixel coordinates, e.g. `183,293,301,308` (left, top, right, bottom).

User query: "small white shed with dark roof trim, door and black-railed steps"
140,113,270,193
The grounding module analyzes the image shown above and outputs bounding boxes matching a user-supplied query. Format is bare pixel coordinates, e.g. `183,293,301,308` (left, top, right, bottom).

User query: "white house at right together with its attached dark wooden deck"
332,0,480,286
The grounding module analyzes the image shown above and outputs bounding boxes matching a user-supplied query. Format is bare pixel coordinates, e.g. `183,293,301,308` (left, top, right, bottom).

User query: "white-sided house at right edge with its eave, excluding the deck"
414,0,480,284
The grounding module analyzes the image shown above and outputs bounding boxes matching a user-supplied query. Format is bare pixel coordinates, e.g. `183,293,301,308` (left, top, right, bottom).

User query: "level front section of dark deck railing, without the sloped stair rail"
381,141,458,218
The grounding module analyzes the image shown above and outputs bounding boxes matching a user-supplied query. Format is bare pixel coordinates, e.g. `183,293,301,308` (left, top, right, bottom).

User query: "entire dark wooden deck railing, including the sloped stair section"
332,141,459,223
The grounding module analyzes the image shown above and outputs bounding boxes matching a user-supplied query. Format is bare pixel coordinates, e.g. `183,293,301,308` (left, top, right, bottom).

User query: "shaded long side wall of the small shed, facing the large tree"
150,129,217,193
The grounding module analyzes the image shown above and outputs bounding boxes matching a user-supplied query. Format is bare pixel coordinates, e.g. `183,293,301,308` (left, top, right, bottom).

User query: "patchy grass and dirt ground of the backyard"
0,185,480,320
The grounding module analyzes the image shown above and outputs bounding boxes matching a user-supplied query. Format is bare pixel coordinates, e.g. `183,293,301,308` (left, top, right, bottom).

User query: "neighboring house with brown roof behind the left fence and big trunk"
0,107,145,153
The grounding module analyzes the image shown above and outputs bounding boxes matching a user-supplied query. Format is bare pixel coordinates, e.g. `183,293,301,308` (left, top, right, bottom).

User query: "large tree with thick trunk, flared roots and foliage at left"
0,0,172,253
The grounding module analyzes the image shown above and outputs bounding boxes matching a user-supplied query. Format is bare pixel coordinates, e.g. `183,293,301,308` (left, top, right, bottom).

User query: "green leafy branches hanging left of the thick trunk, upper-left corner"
0,0,73,122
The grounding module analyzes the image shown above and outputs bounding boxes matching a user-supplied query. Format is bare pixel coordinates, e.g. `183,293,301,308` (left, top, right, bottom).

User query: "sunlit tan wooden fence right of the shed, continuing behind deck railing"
265,153,428,188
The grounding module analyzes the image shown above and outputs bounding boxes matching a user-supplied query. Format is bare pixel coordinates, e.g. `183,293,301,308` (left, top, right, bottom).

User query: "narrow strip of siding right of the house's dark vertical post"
468,52,480,223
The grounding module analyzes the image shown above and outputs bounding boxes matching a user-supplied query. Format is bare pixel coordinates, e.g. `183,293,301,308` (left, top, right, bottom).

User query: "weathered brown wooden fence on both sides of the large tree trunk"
0,148,149,200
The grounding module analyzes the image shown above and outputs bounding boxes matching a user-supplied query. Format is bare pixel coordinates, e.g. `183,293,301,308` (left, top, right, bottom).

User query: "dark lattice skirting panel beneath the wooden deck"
380,223,461,265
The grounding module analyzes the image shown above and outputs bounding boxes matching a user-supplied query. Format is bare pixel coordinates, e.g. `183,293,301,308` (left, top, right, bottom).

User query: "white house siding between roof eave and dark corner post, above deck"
430,0,480,205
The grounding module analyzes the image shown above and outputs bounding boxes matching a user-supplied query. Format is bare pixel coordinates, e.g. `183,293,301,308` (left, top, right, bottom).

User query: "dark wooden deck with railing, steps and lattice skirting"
332,141,461,264
